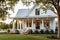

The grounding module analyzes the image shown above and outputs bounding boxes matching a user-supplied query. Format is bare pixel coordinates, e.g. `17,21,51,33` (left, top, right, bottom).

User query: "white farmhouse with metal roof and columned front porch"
11,6,57,32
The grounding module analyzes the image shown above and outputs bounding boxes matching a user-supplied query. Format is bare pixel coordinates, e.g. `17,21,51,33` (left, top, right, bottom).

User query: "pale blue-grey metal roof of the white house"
12,5,57,18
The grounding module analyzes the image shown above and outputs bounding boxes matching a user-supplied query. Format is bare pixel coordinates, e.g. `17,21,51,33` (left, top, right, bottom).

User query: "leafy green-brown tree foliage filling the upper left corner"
0,0,19,20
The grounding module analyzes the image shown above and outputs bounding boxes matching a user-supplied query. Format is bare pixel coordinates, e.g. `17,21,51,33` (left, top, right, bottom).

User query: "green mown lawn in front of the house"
0,34,57,40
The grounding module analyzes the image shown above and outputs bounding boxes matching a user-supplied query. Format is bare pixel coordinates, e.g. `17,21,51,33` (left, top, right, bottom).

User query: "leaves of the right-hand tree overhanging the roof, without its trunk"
21,0,55,12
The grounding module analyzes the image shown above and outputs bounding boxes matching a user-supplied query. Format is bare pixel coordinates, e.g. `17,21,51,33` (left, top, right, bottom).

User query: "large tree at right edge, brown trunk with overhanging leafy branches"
21,0,60,38
